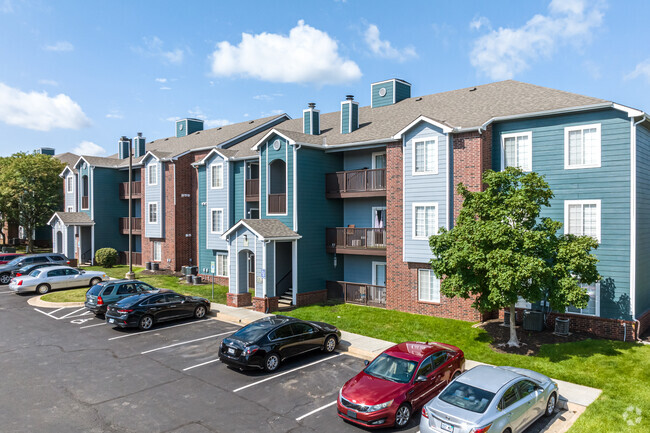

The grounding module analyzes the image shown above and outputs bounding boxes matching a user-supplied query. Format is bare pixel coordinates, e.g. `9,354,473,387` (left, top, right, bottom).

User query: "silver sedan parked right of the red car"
420,365,558,433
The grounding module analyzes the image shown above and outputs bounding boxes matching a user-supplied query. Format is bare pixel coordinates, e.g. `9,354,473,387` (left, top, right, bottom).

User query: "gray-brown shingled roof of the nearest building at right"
264,80,609,145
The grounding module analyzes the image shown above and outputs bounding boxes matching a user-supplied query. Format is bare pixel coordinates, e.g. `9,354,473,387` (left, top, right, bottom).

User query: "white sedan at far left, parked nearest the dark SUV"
9,266,108,295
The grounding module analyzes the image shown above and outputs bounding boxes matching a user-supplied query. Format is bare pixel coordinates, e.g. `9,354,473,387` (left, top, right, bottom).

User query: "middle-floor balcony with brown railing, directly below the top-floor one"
325,227,386,256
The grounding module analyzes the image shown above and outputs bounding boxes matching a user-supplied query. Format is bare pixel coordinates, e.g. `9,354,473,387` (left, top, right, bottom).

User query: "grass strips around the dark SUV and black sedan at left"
42,265,228,304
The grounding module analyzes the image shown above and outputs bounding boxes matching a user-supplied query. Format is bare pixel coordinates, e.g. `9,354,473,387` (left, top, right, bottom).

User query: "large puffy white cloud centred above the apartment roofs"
210,20,361,84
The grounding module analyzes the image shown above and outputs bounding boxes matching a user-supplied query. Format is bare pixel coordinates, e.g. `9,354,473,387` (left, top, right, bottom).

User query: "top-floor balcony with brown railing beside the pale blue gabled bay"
325,168,386,198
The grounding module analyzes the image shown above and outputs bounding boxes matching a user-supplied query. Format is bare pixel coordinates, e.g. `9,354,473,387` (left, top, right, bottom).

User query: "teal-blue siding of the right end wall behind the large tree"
492,110,630,319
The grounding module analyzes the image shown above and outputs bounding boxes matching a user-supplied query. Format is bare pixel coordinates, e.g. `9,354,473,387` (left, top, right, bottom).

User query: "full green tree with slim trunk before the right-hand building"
429,168,600,346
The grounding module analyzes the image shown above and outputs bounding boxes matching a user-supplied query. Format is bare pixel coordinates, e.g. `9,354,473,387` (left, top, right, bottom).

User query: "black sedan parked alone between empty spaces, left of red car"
219,316,341,372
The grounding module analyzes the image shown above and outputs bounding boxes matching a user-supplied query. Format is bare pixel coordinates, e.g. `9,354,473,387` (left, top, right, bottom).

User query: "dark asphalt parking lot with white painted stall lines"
0,288,568,433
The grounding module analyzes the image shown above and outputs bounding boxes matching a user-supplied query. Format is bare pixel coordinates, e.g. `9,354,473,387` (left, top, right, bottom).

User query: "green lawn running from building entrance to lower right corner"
282,304,650,433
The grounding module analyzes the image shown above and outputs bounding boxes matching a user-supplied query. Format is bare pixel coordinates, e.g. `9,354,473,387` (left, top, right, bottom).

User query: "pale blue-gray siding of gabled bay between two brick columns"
403,122,451,263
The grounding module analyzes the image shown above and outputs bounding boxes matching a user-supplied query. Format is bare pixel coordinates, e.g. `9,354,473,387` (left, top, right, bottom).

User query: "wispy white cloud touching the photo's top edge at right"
470,0,604,80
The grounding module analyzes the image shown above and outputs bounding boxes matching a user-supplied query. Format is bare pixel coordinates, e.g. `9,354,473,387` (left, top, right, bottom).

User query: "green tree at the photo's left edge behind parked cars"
0,152,65,251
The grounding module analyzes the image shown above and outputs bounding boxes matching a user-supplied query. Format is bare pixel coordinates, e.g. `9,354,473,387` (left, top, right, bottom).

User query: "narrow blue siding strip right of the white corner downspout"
635,121,650,318
